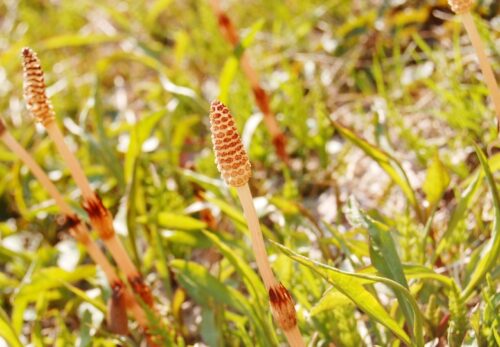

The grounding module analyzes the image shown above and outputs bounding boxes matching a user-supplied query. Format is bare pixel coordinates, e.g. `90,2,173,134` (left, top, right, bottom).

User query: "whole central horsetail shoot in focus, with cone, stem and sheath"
210,100,305,347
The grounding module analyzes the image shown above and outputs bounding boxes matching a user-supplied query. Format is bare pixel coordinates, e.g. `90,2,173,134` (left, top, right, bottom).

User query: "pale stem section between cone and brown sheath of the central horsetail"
236,183,278,291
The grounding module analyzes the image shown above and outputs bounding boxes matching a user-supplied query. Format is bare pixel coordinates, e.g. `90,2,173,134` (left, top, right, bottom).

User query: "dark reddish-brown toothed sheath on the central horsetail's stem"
269,283,297,331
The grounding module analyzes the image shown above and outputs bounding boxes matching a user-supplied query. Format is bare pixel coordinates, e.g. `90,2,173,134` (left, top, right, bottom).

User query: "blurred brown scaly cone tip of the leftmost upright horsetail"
22,47,55,126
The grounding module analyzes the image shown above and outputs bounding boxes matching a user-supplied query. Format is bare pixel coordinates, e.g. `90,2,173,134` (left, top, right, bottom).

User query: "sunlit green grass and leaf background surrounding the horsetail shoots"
0,0,500,346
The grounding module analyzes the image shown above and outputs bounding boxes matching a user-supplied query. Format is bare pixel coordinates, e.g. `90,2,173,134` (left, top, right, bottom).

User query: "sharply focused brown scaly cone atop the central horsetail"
210,100,252,187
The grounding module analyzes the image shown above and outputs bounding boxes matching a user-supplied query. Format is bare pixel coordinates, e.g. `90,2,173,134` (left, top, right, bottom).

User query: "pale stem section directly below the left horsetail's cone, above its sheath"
45,121,94,200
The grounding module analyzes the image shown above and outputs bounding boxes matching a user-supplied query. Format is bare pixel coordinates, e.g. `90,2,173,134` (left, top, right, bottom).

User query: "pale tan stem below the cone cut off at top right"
461,12,500,124
